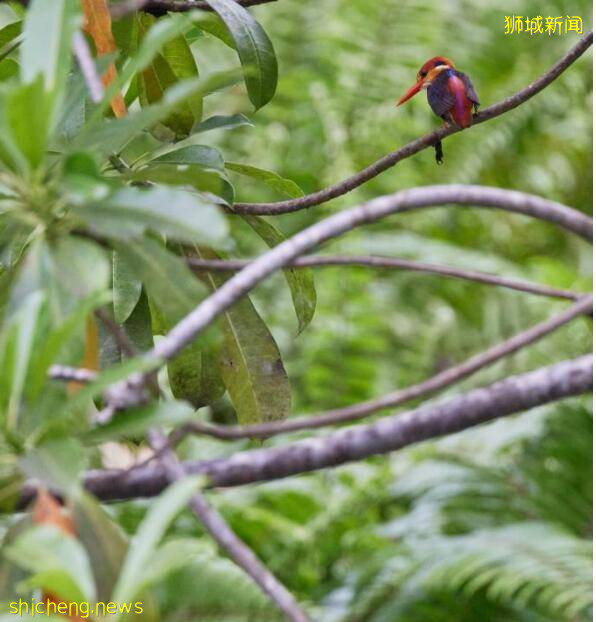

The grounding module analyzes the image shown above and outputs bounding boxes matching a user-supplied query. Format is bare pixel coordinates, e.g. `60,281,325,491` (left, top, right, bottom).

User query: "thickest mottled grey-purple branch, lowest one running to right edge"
72,354,592,504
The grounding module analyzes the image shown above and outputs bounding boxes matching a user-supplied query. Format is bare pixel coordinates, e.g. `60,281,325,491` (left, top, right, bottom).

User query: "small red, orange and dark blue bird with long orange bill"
397,56,480,164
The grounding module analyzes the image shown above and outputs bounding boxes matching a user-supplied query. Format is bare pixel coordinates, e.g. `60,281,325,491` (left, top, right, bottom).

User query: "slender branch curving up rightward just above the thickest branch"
170,296,592,444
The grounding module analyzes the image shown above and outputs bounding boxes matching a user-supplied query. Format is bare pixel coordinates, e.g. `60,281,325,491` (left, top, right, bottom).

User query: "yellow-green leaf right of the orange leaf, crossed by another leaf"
135,12,203,136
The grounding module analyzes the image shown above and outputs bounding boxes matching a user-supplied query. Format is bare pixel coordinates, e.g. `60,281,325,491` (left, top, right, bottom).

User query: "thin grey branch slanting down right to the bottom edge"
149,430,309,622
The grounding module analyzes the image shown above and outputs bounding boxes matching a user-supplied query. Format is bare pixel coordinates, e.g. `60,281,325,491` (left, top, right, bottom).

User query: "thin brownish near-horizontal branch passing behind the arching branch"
186,255,584,300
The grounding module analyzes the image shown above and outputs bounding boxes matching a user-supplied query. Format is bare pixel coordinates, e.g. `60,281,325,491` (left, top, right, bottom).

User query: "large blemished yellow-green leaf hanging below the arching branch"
194,248,290,425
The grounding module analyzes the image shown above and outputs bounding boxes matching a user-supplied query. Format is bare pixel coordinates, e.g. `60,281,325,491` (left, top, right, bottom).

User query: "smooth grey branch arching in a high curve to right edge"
147,184,592,370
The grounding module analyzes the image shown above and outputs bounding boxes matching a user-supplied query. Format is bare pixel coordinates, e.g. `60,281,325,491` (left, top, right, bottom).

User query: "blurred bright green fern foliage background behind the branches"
0,0,592,622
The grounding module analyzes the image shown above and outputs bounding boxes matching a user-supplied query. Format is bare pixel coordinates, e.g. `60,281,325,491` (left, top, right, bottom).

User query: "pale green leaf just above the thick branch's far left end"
19,438,86,497
